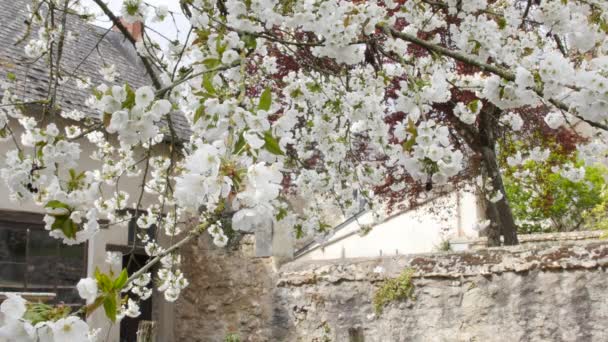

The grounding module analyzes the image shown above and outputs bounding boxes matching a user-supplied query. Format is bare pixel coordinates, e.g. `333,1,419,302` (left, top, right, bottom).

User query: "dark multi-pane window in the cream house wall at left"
0,211,87,305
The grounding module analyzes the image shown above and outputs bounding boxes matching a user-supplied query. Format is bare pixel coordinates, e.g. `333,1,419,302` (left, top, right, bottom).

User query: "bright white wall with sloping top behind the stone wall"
296,191,479,260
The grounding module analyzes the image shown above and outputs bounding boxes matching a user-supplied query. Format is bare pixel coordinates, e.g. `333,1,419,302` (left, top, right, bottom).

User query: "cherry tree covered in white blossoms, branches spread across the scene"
0,0,608,341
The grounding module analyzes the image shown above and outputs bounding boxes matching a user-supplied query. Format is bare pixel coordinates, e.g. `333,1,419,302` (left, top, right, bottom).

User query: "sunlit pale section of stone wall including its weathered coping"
275,242,608,342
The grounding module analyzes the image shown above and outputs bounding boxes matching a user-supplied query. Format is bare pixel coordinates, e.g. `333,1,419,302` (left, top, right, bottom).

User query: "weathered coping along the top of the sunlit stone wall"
277,240,608,287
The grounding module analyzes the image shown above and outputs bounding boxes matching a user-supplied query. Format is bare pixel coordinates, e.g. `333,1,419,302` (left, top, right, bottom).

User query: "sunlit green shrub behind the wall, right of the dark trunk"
499,135,608,234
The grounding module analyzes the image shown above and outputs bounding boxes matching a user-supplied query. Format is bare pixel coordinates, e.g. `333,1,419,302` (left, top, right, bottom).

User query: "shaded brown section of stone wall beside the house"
175,234,275,342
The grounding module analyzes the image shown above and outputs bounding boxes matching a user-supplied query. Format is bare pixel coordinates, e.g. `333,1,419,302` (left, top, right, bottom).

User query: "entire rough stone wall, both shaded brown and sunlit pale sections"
176,241,608,342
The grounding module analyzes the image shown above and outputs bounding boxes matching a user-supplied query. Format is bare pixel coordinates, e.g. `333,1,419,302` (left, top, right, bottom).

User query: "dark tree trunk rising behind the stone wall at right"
478,106,519,246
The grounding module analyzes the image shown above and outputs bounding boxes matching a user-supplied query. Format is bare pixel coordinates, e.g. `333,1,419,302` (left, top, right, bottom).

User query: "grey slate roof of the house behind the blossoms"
0,0,190,139
